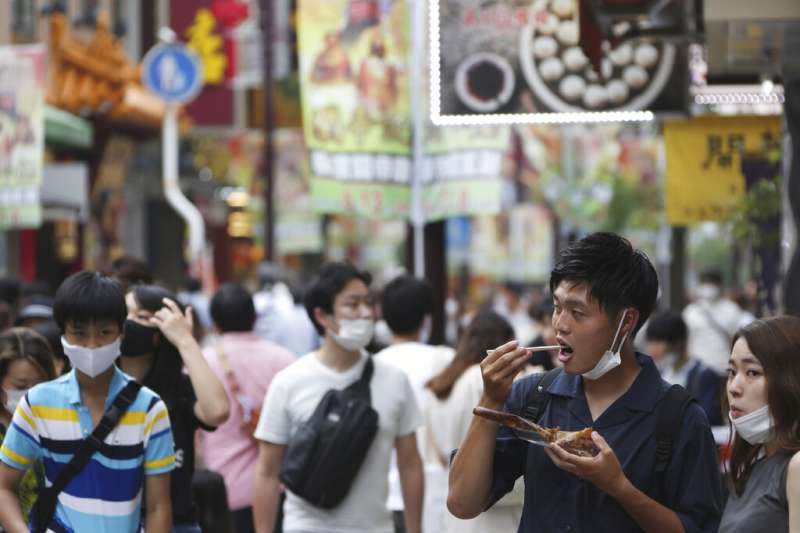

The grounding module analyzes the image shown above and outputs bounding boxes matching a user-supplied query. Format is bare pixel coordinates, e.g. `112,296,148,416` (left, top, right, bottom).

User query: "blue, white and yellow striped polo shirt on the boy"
0,367,175,533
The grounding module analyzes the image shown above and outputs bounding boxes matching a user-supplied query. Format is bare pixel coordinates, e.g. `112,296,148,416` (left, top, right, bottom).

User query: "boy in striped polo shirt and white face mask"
0,272,175,533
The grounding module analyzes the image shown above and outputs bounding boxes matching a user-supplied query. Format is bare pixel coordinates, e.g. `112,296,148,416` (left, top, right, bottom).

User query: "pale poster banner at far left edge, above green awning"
0,45,45,229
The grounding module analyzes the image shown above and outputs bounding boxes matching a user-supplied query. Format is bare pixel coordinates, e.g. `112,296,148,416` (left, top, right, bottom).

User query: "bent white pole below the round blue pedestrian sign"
161,104,206,268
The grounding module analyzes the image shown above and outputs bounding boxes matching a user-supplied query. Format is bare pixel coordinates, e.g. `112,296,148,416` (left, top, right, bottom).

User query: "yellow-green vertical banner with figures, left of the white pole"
298,0,411,218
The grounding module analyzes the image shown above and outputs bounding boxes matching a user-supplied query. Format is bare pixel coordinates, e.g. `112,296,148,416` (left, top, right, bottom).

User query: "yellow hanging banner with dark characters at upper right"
664,116,781,226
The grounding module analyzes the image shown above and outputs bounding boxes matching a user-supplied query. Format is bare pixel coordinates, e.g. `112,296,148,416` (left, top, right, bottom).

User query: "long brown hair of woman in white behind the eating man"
426,310,514,400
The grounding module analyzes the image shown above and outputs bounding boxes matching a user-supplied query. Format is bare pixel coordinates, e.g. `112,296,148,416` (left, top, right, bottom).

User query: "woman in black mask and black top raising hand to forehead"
118,285,228,533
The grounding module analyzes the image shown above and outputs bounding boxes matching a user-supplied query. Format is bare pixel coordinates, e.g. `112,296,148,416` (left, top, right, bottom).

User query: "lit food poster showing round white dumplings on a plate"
438,0,688,118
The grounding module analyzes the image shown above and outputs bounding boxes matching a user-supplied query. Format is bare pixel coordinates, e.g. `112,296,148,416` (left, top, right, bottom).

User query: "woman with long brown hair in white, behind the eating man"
423,310,522,533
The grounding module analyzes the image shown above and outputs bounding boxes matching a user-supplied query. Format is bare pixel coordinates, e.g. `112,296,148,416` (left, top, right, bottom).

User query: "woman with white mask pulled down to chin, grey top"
719,316,800,533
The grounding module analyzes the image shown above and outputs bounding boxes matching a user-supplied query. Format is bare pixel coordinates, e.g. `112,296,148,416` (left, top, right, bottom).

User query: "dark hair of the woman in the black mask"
131,285,185,412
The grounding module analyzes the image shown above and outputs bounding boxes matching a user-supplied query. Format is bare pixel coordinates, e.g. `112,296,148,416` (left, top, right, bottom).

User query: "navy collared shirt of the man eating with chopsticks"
492,354,722,533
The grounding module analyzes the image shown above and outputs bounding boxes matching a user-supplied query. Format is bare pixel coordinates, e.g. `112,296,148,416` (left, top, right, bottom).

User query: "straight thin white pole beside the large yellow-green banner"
411,0,426,278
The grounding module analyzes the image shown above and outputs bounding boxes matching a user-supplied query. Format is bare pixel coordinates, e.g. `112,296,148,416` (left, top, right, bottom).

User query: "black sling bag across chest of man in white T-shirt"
280,358,378,509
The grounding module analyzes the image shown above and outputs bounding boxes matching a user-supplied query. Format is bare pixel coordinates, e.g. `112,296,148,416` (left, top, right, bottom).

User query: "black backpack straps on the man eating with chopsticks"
524,368,694,494
